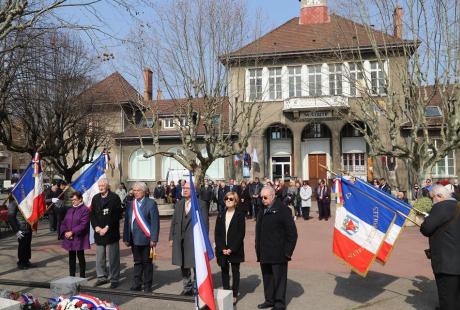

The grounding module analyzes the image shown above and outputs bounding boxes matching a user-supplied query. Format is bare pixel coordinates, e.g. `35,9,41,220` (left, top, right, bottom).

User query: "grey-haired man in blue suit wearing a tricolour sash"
123,182,160,293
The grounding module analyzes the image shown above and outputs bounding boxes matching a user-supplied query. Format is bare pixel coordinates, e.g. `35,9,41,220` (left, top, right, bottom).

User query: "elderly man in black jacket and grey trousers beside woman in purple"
90,178,122,288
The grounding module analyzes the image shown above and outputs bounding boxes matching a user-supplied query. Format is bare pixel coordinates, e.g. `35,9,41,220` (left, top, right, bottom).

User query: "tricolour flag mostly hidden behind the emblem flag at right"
355,179,412,264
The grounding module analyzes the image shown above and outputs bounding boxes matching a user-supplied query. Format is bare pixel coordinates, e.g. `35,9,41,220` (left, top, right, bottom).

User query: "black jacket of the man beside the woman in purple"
90,191,122,245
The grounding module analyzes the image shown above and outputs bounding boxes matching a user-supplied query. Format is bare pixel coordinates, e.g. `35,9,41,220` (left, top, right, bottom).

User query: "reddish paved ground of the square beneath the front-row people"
0,202,437,310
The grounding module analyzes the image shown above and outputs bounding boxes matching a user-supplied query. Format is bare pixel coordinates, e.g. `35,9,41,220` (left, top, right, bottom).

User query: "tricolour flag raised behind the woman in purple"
72,153,106,207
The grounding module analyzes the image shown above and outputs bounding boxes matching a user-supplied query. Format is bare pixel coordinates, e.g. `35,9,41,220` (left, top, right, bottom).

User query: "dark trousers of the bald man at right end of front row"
260,263,287,309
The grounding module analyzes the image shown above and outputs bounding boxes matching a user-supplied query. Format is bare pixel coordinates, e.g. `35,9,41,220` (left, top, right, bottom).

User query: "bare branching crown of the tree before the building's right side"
326,0,460,188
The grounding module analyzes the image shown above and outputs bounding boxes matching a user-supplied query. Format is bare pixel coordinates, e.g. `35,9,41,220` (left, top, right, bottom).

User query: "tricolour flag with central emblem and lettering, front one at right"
332,177,396,276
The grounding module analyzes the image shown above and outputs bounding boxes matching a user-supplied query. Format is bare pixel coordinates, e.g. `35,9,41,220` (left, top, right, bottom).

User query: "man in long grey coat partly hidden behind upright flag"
169,183,208,296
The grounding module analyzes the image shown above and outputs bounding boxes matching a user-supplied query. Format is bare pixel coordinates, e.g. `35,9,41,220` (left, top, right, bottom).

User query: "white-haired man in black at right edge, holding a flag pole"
420,185,460,310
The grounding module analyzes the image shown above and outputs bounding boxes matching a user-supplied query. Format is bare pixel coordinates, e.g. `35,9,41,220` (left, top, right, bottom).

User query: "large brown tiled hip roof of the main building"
226,14,409,59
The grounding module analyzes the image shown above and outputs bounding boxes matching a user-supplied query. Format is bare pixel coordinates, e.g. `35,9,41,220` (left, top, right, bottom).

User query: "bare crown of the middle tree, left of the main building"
125,0,260,183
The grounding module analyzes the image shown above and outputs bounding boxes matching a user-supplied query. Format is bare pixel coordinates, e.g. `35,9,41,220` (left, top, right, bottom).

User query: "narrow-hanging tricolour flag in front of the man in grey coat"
190,172,216,310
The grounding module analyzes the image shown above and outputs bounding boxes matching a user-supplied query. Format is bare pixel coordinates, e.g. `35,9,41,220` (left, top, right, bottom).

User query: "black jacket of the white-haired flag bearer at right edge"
420,199,460,275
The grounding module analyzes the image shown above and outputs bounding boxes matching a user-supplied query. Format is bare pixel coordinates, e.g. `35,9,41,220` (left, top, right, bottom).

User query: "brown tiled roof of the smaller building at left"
82,72,142,103
